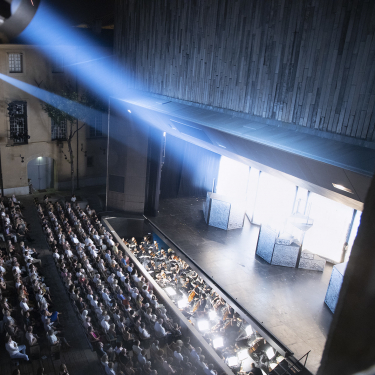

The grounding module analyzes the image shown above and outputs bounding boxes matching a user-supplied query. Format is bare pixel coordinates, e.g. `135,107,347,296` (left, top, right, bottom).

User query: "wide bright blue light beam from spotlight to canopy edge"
19,2,132,104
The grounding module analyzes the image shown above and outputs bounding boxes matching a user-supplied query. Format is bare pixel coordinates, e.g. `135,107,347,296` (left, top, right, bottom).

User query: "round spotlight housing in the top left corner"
0,0,40,44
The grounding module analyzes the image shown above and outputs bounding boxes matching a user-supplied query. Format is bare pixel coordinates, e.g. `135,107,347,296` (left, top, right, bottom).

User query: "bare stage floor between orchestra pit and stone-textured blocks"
149,198,332,374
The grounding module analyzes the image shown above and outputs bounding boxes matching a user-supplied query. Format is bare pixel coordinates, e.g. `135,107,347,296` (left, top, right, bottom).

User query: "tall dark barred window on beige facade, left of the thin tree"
8,101,28,144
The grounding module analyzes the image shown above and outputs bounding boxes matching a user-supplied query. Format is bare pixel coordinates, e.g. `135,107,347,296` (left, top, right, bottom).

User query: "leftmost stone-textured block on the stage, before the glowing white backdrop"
203,193,245,230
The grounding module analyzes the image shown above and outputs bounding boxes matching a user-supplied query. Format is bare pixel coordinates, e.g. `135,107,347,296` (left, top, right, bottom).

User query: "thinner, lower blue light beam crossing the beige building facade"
0,73,101,131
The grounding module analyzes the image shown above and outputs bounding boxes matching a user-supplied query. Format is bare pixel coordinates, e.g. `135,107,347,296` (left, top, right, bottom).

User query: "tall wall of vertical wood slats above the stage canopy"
115,0,375,141
